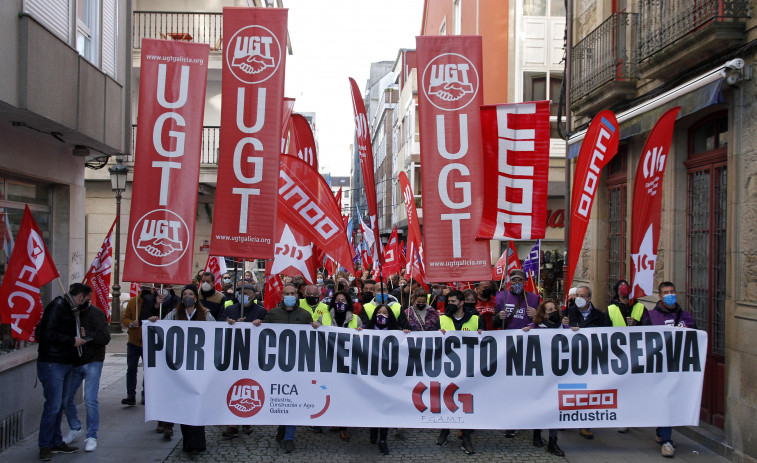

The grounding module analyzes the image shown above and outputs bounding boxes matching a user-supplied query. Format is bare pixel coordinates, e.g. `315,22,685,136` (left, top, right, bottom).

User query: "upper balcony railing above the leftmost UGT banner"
131,11,223,51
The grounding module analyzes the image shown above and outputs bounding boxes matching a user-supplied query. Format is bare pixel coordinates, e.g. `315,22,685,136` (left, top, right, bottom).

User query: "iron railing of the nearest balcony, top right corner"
638,0,749,61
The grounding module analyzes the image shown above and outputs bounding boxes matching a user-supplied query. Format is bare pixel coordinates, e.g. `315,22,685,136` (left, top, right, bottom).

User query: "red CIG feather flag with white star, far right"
631,106,681,299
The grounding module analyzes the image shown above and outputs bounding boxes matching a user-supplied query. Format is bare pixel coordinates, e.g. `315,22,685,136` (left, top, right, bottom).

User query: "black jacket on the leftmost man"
35,296,78,364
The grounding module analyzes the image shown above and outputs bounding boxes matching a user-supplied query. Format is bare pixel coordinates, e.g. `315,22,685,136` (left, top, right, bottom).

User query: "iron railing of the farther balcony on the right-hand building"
571,12,637,101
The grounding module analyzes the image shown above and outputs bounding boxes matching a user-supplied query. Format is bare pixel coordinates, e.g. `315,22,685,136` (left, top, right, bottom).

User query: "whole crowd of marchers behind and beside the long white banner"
37,269,696,461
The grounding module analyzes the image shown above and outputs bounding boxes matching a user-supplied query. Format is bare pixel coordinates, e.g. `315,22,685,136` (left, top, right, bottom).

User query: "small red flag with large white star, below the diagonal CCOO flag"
266,219,318,285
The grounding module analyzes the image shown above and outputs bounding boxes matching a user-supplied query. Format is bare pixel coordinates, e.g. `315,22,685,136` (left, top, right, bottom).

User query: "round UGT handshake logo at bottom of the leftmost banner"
131,209,189,267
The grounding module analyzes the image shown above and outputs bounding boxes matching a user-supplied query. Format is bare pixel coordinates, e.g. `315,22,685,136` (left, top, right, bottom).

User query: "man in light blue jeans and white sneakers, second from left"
63,290,110,452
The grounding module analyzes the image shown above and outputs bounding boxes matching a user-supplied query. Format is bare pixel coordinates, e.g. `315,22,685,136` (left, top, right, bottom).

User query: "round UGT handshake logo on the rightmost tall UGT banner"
423,53,479,111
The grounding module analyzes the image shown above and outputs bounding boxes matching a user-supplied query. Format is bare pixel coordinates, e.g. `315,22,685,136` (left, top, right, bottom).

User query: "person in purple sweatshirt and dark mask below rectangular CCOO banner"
492,268,539,334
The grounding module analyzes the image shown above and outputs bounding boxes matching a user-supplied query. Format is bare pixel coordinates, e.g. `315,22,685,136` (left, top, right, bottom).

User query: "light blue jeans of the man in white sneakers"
63,362,103,439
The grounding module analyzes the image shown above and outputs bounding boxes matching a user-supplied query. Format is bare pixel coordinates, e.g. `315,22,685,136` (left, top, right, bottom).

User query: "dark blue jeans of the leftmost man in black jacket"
37,361,73,448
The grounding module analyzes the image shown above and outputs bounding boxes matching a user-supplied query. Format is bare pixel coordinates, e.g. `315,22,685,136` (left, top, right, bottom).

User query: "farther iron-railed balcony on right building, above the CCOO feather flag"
570,12,637,115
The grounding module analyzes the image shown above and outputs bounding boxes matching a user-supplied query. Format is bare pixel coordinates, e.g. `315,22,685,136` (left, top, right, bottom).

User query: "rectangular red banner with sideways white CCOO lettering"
476,101,549,240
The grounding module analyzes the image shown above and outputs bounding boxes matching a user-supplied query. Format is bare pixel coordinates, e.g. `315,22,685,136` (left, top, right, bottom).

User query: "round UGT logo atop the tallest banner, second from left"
225,26,281,84
